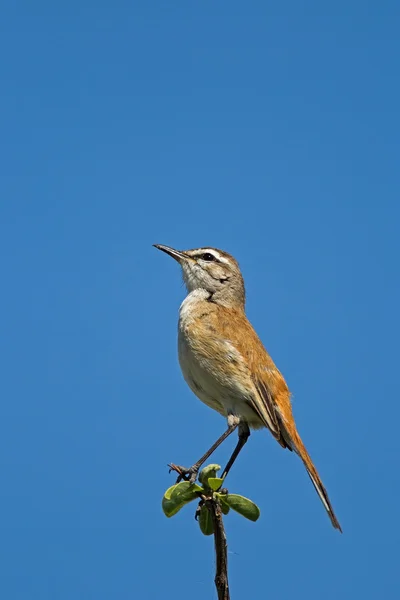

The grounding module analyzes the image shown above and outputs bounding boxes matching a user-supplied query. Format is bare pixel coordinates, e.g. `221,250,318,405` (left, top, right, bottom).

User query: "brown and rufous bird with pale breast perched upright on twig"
154,244,342,532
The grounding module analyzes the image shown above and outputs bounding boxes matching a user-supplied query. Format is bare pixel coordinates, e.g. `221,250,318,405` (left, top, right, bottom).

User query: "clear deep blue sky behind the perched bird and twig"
0,0,400,600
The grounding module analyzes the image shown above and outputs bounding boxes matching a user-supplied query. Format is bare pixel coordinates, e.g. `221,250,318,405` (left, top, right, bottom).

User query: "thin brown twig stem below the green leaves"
206,498,230,600
